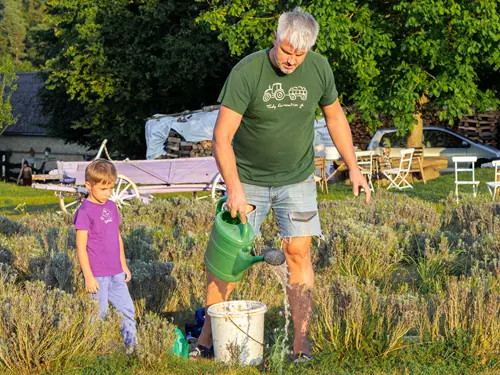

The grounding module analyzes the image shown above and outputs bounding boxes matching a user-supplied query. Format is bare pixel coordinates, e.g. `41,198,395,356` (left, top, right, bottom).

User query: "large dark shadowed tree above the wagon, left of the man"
41,0,238,158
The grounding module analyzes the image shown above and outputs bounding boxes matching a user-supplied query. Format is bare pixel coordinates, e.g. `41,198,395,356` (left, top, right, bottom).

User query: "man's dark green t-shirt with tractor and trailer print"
219,49,337,186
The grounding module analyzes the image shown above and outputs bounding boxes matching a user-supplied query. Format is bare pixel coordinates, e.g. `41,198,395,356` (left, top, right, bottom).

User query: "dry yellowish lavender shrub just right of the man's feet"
311,276,425,356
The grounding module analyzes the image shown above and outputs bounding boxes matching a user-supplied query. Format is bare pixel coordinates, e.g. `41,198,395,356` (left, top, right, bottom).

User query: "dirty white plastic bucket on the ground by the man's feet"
207,301,267,366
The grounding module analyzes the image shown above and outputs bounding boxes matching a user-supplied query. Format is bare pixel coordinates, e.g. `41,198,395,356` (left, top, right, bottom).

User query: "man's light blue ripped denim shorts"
243,175,322,238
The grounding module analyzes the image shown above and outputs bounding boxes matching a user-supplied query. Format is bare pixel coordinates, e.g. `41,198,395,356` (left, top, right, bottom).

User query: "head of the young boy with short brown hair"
85,159,117,204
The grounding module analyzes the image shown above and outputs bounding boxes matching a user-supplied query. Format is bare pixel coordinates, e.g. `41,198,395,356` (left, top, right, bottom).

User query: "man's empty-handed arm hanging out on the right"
321,99,371,203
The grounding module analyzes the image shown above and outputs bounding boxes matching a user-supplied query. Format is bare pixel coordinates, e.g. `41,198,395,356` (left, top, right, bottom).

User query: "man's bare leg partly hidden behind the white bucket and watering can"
198,270,236,348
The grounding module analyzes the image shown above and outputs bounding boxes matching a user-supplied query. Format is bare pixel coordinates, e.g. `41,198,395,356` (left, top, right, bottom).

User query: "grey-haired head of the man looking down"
271,8,319,74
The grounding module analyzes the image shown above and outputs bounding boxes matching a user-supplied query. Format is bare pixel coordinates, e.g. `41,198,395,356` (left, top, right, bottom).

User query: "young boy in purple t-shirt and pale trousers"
74,159,137,353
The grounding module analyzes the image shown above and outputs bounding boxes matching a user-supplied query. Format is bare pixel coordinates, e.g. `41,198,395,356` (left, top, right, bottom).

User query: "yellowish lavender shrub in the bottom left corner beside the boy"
0,278,120,373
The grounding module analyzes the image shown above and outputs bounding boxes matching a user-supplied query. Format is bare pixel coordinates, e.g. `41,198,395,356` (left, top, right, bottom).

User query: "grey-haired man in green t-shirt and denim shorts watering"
190,9,370,362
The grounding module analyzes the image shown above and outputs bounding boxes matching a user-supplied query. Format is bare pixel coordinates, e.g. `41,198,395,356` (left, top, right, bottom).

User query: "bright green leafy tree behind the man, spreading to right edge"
197,0,500,145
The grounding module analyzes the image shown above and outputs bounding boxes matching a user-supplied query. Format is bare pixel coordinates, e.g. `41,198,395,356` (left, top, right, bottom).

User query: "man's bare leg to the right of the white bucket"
283,237,314,355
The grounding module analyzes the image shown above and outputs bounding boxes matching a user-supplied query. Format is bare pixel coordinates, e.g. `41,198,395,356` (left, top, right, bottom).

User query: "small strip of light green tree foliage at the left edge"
0,56,17,135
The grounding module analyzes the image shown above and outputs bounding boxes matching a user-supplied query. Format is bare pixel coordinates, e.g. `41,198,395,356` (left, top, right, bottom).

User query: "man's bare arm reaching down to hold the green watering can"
212,105,247,222
